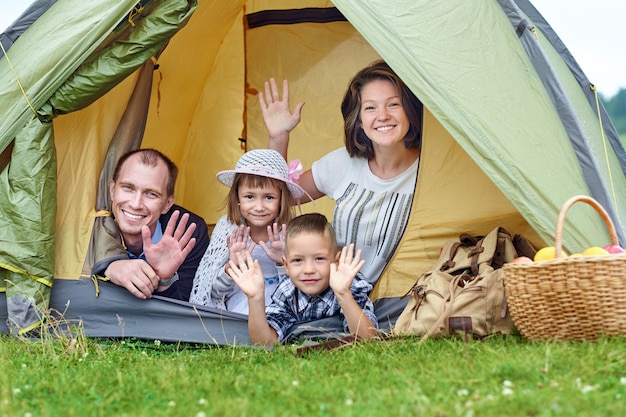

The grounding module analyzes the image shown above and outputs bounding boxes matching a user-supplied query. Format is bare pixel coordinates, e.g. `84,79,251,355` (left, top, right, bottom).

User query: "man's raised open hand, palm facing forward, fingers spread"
141,210,196,280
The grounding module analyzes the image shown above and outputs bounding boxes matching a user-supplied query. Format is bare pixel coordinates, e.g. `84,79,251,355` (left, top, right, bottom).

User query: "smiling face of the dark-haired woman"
360,80,411,149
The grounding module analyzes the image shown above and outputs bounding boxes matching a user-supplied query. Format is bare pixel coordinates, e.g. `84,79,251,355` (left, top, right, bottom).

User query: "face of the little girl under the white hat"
237,181,280,229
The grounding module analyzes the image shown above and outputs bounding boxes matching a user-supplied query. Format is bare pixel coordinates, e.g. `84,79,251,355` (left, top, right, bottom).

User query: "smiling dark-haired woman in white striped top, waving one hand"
259,61,423,324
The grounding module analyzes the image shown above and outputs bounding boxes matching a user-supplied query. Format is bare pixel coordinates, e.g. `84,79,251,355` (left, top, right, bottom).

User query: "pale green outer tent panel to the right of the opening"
335,0,626,247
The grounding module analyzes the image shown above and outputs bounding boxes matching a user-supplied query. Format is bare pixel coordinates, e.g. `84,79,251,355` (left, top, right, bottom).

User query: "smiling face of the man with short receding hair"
109,155,174,249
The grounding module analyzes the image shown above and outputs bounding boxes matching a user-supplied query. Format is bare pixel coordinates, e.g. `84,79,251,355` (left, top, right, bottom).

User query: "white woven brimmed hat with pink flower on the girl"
217,149,313,201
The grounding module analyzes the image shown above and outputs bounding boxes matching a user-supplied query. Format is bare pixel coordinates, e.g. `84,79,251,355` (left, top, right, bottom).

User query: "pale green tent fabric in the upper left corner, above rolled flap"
0,0,137,151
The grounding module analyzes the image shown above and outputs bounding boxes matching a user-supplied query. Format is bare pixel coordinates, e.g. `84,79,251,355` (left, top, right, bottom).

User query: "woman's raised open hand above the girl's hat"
259,78,304,138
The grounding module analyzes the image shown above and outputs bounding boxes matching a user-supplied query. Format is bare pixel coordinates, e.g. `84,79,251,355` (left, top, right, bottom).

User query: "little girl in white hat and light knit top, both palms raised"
189,149,305,314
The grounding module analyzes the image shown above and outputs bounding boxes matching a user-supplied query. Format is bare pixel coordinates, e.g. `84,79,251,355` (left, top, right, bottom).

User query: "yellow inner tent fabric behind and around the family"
55,2,541,298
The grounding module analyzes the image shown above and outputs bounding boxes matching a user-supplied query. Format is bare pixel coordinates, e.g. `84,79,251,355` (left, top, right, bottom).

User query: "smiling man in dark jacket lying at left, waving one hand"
94,149,209,301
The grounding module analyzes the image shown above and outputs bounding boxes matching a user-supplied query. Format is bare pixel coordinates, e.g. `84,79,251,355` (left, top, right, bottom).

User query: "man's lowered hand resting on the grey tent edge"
104,259,159,300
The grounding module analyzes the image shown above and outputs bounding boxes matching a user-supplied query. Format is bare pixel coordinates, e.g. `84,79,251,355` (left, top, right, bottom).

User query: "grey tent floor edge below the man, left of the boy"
50,278,250,345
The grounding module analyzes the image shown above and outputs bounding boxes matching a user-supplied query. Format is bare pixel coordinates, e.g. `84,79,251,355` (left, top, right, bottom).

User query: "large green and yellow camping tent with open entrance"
0,0,626,344
